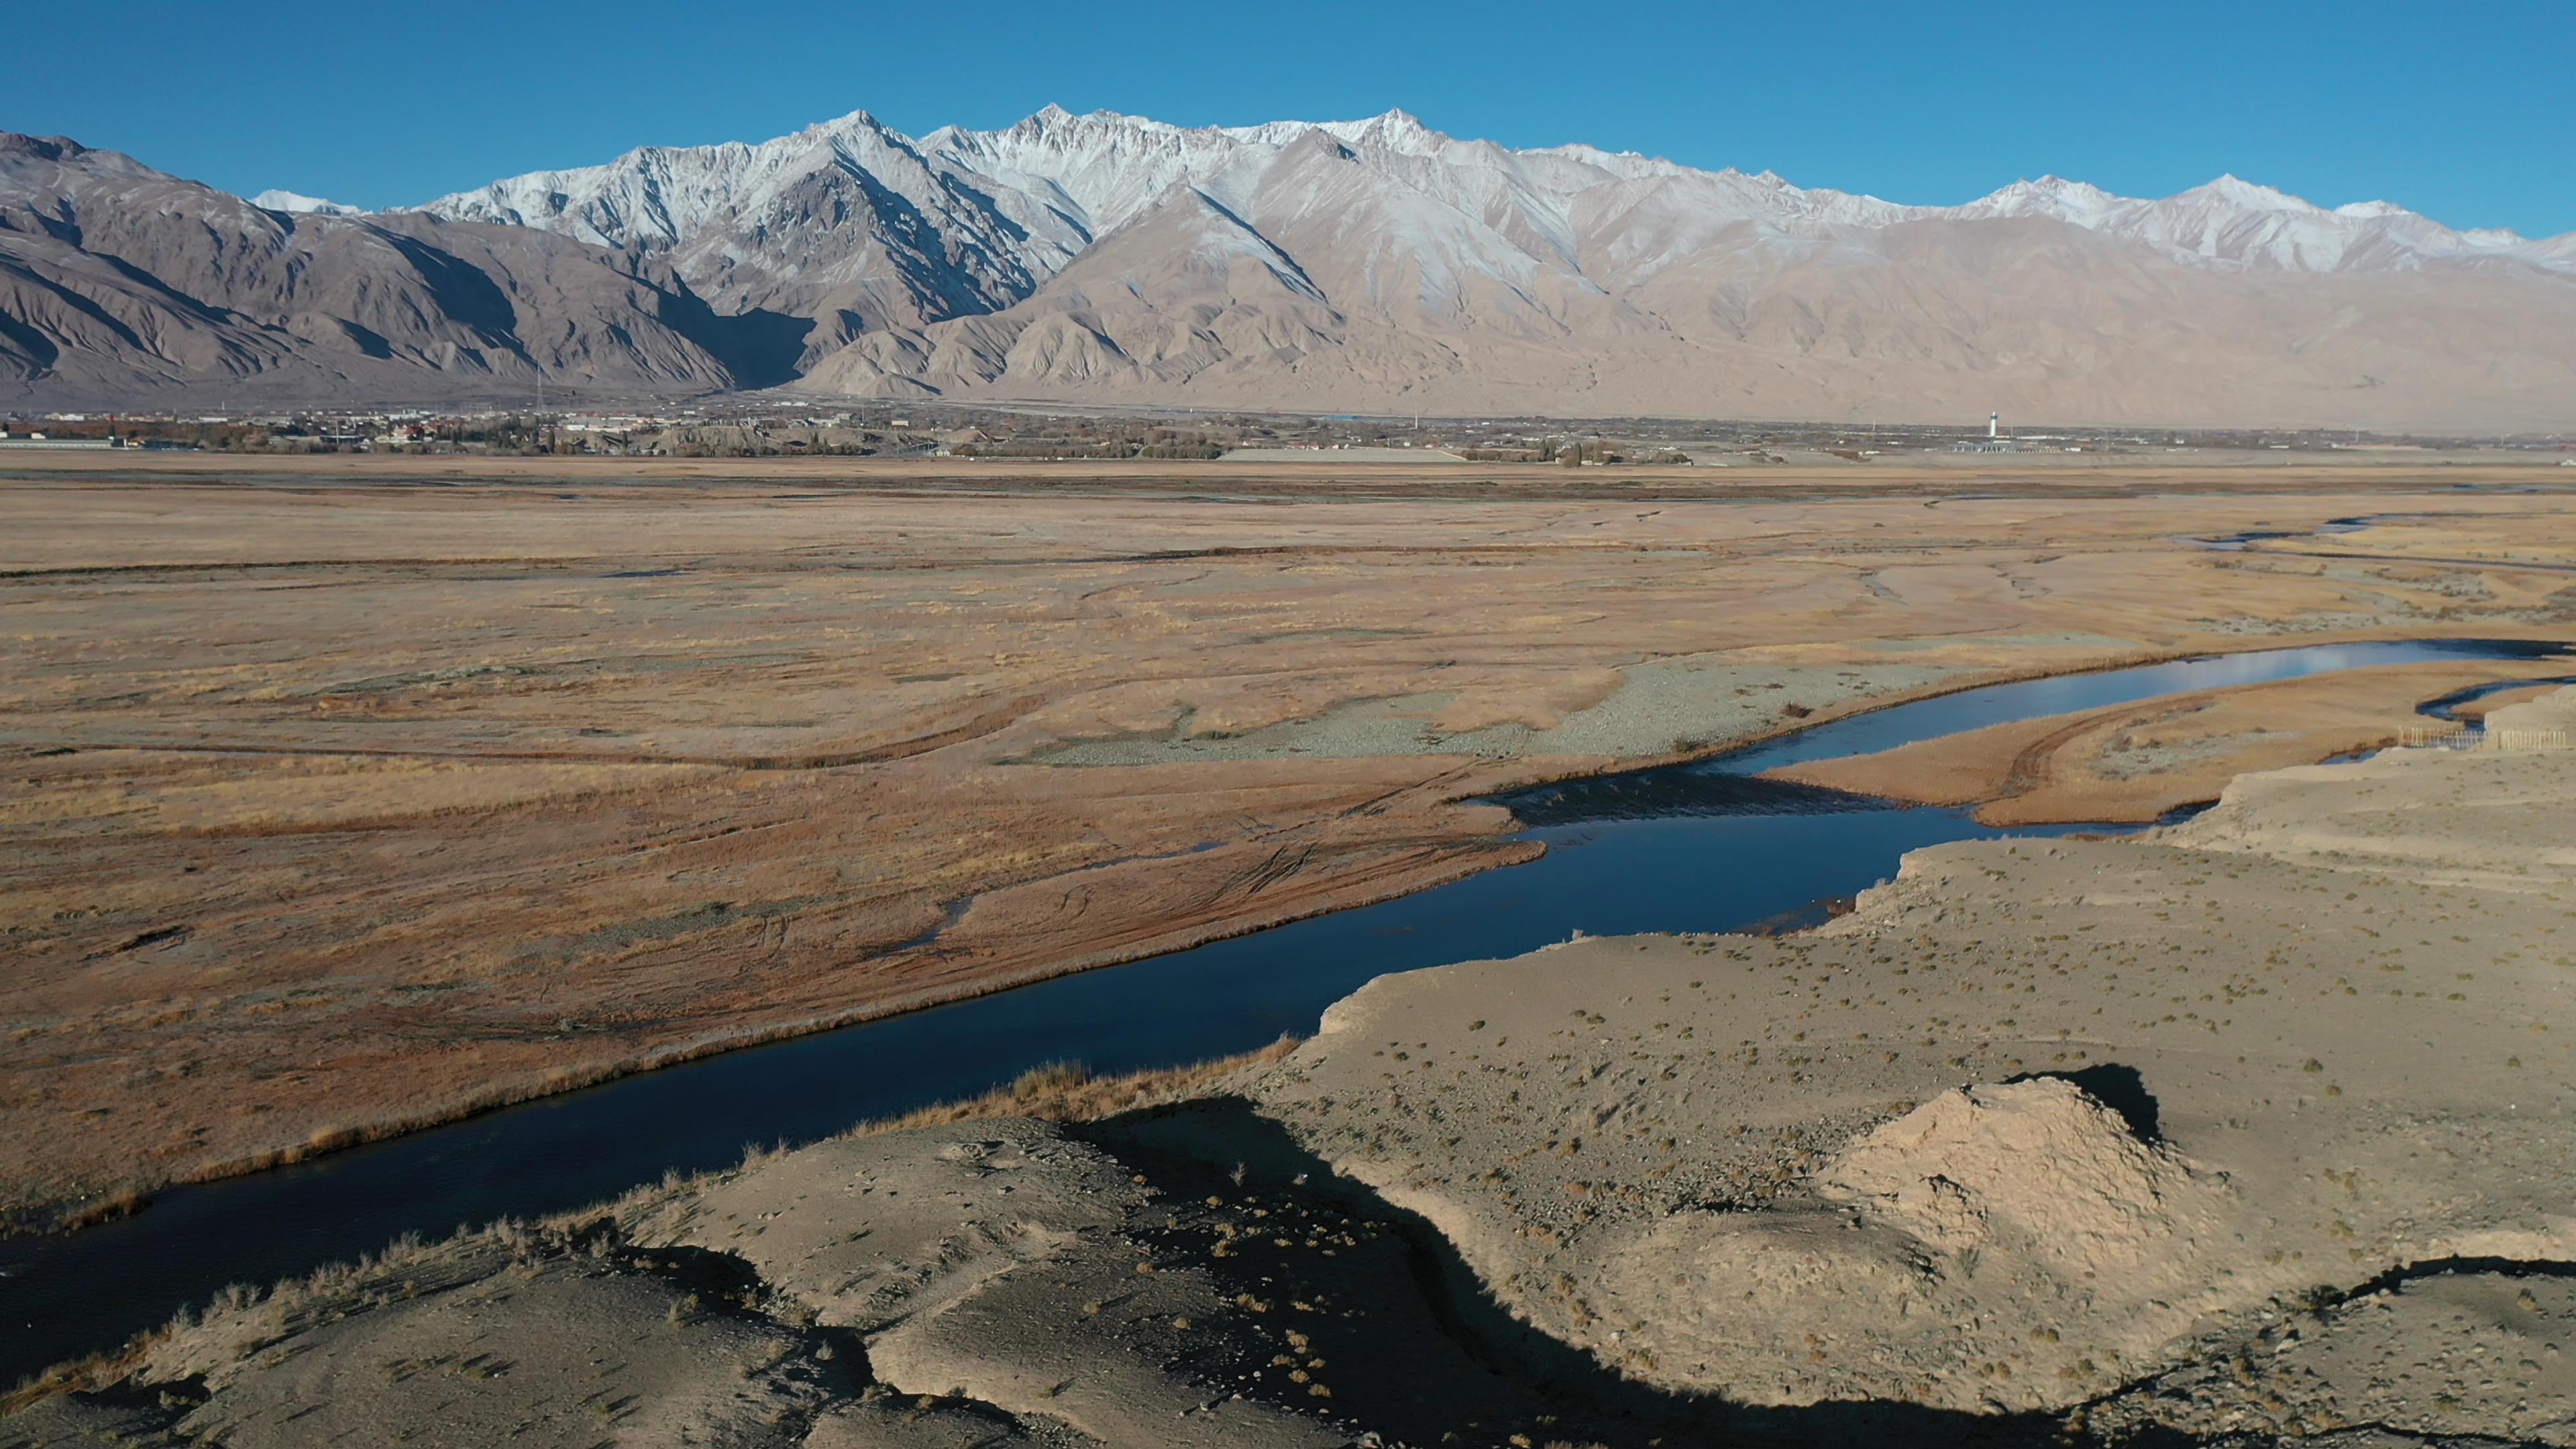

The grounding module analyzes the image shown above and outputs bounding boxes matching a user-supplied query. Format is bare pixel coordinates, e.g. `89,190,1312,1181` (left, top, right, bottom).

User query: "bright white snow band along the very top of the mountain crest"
417,106,2576,278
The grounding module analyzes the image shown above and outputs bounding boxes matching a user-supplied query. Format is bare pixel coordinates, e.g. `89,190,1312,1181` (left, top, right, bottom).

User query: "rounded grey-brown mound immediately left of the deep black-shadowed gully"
644,1119,1332,1449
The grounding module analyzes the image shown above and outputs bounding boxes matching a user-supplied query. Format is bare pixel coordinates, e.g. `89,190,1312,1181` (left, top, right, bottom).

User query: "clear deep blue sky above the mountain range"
20,0,2576,235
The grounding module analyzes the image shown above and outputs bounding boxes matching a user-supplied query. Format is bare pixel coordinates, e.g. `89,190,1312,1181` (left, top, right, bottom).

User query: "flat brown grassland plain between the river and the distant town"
0,459,2576,1222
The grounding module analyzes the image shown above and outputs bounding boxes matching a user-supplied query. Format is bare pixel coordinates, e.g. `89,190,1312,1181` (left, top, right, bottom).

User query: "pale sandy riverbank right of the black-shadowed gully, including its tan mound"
1260,691,2576,1439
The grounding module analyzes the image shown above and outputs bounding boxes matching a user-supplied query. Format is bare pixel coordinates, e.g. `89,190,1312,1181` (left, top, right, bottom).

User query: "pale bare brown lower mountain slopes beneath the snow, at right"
798,195,2576,431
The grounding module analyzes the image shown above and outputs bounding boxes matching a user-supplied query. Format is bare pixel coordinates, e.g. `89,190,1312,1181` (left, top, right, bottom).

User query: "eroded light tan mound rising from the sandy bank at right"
1566,1078,2226,1410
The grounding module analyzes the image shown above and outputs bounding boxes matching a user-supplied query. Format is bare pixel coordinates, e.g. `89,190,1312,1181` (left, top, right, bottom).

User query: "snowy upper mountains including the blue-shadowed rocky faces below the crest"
396,106,2576,340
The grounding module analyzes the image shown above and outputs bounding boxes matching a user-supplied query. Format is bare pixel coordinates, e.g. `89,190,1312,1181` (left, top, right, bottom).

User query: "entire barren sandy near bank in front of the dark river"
20,688,2576,1449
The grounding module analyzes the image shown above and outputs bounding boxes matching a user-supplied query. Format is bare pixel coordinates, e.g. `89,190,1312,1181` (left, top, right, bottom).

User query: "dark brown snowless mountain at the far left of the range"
0,134,804,405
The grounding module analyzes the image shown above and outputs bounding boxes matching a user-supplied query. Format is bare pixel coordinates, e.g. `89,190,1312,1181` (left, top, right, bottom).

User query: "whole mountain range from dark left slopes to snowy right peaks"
0,106,2576,431
